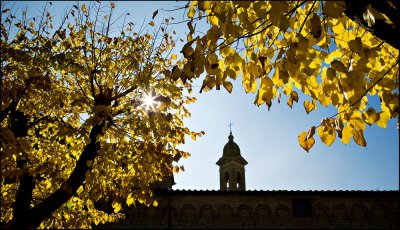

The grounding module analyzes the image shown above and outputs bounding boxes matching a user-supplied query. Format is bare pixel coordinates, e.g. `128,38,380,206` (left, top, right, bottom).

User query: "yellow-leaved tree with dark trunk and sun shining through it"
1,2,200,229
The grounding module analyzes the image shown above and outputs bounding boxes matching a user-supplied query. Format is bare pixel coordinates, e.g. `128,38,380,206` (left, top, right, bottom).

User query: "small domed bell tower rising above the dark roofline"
216,131,247,191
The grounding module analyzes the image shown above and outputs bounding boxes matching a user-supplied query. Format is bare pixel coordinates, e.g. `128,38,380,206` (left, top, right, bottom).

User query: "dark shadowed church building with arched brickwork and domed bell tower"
99,132,399,229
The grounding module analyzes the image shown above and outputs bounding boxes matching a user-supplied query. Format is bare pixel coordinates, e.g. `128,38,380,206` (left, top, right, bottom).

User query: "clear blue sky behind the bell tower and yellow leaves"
10,1,399,190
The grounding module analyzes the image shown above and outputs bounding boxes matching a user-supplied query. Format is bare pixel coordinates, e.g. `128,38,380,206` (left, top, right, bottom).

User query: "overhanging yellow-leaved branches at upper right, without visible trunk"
183,1,400,151
